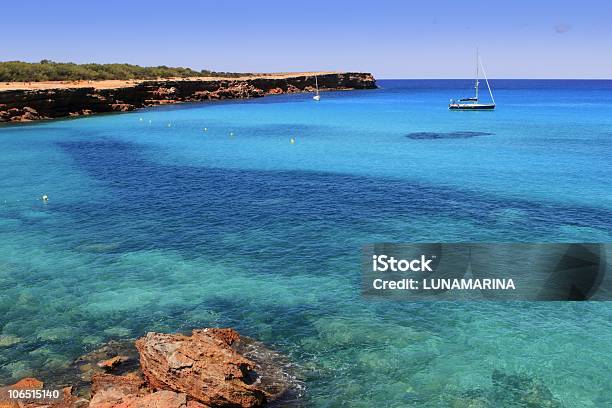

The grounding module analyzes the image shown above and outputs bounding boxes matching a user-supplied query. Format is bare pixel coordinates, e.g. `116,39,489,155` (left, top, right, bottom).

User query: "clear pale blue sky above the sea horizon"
0,0,612,79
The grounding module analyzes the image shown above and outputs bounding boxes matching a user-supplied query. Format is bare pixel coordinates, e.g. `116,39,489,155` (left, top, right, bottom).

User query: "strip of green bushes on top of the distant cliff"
0,60,245,82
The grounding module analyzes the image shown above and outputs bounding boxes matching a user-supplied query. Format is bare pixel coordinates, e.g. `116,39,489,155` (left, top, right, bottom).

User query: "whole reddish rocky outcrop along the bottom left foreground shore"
0,329,303,408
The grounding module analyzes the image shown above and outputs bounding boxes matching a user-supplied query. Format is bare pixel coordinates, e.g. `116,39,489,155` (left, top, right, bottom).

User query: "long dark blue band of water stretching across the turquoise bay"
58,140,612,255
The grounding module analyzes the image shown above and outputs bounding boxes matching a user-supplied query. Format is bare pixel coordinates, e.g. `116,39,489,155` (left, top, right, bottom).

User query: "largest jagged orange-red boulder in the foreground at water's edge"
136,329,266,407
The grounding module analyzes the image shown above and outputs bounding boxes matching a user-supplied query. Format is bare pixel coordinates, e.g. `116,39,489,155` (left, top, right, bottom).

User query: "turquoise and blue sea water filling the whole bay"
0,81,612,407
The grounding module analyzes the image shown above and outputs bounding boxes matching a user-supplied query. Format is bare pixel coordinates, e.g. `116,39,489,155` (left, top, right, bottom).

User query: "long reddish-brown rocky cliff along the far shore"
0,73,376,122
